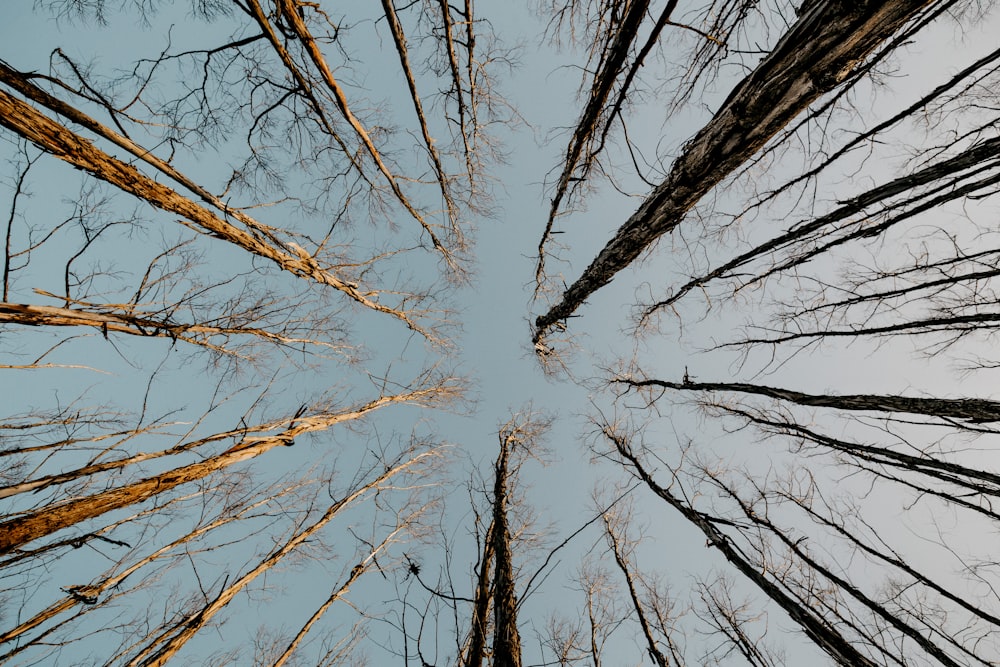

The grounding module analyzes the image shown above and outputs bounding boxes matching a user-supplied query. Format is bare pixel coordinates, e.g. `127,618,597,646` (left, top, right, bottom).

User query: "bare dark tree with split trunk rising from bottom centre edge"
384,410,564,667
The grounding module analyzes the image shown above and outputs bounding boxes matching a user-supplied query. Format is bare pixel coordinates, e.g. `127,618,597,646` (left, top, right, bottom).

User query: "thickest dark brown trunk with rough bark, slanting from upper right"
534,0,930,347
